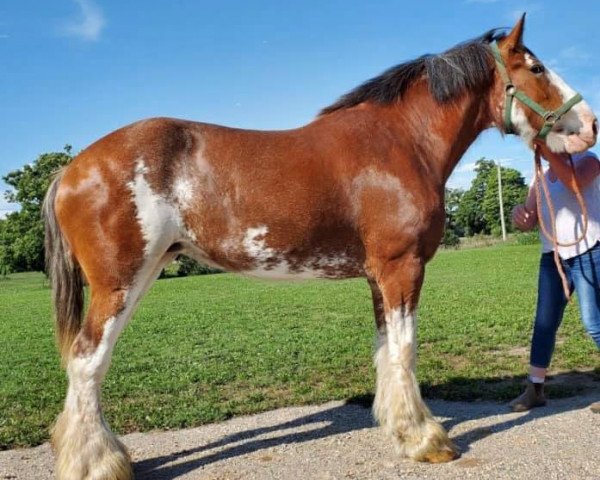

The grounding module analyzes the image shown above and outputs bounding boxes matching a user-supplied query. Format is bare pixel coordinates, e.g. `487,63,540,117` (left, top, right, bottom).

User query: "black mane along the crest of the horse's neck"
320,29,505,115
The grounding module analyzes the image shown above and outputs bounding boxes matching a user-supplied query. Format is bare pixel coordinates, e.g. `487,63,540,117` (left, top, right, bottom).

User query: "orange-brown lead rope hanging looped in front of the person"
534,145,588,301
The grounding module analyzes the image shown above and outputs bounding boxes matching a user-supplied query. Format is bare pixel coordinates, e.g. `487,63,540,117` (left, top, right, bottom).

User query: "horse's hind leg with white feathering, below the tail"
52,253,174,480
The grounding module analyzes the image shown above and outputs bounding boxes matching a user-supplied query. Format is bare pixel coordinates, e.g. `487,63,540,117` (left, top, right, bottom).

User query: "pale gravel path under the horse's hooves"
0,389,600,480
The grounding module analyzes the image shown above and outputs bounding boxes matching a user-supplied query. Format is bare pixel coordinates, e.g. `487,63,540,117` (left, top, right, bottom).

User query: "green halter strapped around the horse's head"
490,43,583,140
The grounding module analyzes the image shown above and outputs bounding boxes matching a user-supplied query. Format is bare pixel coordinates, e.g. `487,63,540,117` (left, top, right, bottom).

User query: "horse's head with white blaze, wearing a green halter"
491,15,598,153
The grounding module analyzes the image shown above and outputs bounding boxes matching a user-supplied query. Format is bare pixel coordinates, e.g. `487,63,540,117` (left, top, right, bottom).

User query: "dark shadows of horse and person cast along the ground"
135,370,600,480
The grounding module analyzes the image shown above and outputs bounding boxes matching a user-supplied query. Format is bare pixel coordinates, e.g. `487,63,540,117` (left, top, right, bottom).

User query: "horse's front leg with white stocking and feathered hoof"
369,255,458,463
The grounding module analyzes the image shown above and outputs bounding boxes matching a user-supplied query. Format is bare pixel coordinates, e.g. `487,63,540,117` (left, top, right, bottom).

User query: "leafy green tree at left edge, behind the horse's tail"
0,145,73,272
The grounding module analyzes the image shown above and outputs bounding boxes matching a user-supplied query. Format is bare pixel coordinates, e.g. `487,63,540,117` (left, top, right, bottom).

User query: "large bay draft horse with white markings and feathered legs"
43,17,597,480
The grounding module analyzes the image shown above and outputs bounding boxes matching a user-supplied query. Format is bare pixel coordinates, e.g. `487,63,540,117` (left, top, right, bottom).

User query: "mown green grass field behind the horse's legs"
0,246,600,449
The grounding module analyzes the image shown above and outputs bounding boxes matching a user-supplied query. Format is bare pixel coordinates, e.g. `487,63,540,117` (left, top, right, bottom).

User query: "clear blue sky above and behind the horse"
0,0,600,214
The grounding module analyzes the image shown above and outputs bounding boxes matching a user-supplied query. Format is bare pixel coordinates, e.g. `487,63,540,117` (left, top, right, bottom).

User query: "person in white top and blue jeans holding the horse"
510,151,600,413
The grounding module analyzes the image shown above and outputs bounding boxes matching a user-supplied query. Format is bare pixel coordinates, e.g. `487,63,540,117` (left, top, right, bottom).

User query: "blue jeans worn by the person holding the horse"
530,242,600,368
